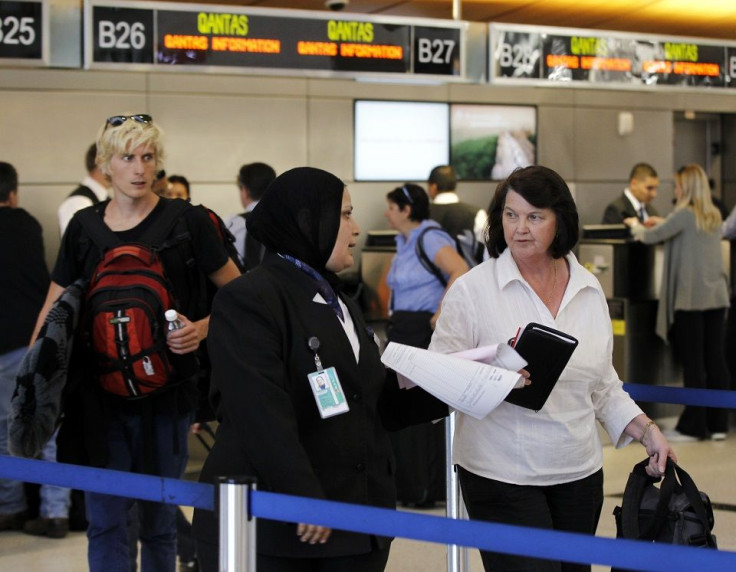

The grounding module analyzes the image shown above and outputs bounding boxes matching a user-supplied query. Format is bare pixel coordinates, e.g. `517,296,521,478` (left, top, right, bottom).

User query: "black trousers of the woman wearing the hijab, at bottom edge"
197,539,391,572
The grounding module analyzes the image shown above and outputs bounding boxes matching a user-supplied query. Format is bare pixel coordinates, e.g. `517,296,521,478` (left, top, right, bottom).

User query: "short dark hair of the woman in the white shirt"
486,165,579,258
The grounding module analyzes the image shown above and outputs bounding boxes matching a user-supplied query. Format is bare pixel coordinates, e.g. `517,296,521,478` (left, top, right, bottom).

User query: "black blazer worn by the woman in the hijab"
194,252,447,557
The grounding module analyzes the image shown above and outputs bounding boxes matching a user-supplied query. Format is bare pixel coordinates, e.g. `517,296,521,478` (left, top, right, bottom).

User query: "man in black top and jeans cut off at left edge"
0,162,69,538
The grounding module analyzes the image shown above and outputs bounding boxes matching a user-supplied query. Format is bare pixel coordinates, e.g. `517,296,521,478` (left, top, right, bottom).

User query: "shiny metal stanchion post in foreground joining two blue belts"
217,477,256,572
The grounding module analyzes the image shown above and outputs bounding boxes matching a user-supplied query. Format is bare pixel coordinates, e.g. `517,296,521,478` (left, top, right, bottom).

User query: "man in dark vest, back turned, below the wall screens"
427,165,488,242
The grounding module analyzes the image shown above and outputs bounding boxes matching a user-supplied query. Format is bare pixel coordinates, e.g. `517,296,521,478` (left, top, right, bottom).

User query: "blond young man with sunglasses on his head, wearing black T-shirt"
36,114,239,572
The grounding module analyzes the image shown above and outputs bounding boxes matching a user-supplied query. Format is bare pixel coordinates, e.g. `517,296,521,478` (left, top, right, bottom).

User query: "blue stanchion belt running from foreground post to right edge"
251,491,736,572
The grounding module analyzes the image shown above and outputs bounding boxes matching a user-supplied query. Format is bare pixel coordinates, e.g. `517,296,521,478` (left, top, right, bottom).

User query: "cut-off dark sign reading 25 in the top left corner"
0,0,48,63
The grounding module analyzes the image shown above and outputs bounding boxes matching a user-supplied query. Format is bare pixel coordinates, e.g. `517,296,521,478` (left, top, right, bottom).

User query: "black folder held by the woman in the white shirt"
506,322,578,411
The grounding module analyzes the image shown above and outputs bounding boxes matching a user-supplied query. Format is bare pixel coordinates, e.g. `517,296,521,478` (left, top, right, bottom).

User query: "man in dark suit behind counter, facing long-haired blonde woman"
601,163,660,226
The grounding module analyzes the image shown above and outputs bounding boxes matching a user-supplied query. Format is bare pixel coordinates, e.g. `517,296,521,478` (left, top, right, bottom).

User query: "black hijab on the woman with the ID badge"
248,167,345,274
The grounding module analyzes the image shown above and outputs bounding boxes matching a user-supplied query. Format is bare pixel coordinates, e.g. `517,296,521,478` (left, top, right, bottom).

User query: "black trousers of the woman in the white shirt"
458,466,603,572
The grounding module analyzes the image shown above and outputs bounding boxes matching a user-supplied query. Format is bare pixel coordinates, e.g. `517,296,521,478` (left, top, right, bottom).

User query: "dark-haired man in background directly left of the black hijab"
226,163,276,272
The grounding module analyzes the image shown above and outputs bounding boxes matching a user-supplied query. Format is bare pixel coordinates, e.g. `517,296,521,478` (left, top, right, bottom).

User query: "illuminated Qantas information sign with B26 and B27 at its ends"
87,0,462,76
